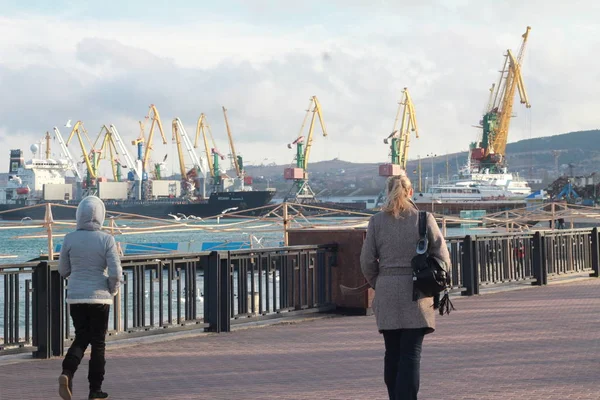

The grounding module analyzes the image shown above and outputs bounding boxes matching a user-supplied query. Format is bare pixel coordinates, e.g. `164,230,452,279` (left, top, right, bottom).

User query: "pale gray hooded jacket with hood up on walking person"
58,196,123,304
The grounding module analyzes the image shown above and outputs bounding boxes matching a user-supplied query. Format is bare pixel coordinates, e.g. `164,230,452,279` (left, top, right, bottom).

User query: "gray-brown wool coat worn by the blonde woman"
360,208,450,333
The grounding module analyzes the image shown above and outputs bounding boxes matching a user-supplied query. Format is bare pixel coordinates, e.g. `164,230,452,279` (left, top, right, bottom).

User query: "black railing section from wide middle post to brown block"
205,245,337,332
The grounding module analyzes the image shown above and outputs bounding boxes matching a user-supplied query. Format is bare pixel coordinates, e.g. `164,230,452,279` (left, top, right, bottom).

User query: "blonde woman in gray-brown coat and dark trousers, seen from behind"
360,174,450,400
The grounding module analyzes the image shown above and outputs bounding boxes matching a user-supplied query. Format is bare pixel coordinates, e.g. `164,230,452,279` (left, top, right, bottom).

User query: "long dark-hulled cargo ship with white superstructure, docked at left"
0,146,275,220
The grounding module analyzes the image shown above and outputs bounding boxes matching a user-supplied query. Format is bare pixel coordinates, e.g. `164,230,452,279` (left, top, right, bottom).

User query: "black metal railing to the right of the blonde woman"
458,228,600,296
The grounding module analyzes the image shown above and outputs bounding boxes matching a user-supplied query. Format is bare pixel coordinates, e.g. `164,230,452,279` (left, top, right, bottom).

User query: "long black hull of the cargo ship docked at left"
0,191,273,221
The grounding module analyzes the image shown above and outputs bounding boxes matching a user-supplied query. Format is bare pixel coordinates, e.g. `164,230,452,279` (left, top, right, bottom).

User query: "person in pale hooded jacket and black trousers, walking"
58,196,123,400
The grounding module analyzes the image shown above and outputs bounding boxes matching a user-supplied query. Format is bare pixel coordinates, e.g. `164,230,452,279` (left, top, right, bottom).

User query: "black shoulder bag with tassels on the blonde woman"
411,211,455,315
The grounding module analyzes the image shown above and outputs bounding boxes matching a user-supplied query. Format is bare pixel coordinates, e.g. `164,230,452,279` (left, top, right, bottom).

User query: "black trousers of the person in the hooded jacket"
62,304,110,392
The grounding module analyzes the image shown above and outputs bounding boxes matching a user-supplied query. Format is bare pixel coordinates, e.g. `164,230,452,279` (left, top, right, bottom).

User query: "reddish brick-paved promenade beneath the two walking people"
0,279,600,400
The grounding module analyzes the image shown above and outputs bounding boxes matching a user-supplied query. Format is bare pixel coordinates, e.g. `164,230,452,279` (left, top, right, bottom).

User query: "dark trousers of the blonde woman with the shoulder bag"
382,329,425,400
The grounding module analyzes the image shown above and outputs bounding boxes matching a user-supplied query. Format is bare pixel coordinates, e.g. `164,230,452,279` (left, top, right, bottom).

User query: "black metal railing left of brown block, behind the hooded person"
0,245,337,358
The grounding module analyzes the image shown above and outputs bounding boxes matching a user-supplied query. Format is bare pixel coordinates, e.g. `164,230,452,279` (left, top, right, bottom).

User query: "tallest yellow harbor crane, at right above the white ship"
470,26,531,172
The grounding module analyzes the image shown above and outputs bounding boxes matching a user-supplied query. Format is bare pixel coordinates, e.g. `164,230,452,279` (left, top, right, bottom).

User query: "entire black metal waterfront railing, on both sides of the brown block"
0,228,600,358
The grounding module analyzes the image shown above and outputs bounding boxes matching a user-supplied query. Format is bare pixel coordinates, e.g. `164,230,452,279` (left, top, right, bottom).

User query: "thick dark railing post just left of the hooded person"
31,261,52,358
